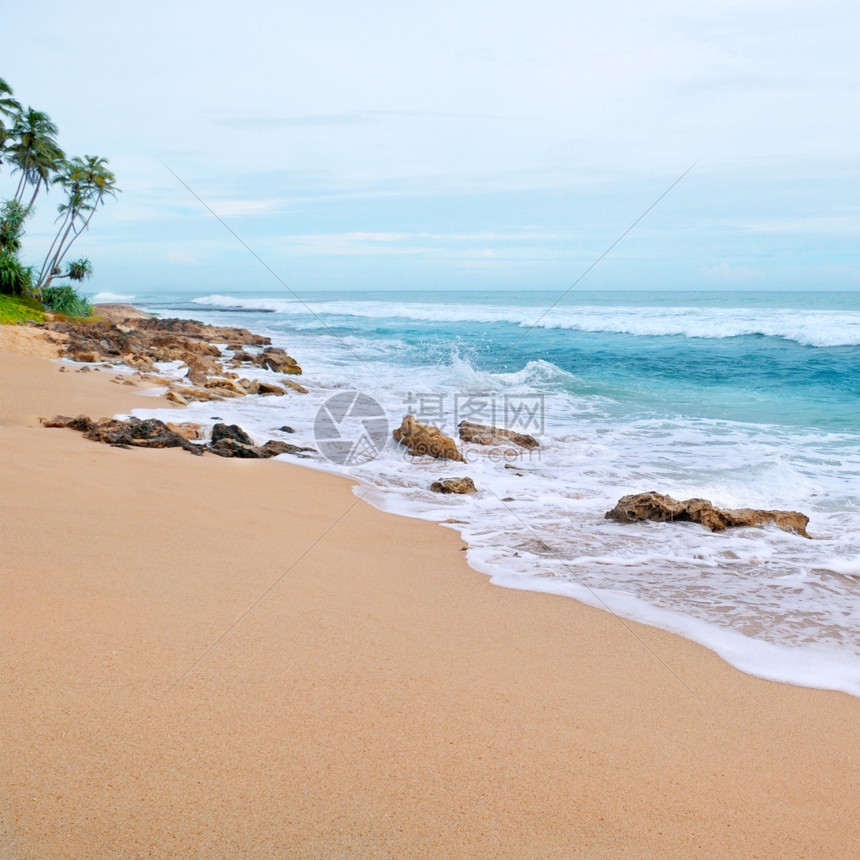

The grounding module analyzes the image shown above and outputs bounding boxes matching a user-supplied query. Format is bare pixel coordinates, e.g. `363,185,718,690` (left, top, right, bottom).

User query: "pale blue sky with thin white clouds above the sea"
0,0,860,295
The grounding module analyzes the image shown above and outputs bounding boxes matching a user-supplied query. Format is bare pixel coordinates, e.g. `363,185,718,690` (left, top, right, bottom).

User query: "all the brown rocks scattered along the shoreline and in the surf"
35,305,809,538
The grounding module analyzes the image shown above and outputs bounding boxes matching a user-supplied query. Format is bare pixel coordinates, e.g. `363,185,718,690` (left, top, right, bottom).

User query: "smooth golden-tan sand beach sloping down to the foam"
0,326,860,860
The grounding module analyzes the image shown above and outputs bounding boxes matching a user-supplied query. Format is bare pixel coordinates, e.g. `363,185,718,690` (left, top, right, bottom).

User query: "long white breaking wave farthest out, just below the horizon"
194,294,860,347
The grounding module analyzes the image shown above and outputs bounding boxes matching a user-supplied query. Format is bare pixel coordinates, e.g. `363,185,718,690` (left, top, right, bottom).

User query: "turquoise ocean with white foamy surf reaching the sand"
106,287,860,695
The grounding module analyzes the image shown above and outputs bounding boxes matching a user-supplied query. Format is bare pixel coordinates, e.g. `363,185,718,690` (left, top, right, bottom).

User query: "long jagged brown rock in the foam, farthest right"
606,491,809,538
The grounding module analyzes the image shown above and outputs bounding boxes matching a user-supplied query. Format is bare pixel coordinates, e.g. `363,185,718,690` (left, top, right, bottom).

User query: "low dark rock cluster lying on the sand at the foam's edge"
41,415,313,460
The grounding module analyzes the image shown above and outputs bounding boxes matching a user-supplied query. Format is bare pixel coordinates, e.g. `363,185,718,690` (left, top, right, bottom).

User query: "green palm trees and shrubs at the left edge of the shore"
0,78,119,322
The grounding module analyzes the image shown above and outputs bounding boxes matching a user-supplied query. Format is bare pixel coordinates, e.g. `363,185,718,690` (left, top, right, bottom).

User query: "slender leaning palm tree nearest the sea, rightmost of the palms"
36,155,119,290
